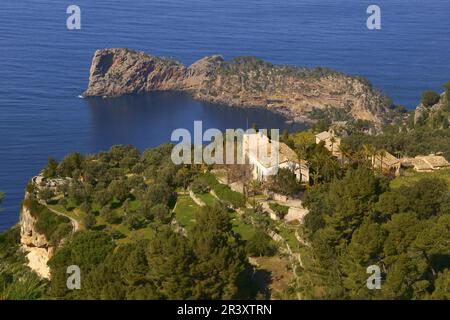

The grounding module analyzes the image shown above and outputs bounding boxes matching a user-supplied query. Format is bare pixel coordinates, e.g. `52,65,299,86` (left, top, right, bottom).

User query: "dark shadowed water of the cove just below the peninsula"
85,92,304,149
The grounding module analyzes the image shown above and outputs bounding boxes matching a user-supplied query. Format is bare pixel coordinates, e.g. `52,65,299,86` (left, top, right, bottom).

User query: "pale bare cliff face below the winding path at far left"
20,206,54,279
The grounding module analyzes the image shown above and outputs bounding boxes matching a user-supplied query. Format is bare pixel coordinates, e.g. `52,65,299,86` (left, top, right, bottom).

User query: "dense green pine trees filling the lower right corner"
300,167,450,300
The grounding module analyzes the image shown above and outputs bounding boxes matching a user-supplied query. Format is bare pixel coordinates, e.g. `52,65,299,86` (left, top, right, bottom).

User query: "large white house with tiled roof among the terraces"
243,133,309,184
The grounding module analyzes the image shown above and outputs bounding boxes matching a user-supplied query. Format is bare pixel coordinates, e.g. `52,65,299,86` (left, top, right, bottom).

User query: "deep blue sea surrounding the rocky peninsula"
0,0,450,231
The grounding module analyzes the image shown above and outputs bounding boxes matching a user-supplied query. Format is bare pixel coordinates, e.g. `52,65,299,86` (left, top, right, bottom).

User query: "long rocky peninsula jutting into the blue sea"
84,49,398,124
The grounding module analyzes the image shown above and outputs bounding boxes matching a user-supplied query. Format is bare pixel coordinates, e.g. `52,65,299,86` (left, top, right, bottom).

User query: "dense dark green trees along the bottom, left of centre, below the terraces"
49,207,255,299
